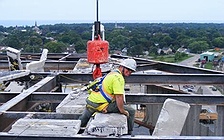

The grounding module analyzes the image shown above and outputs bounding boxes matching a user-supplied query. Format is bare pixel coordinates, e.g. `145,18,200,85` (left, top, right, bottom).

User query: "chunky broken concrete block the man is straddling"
86,113,128,136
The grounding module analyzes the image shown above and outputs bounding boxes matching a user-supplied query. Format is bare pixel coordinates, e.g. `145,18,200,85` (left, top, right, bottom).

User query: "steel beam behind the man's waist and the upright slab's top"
2,92,224,105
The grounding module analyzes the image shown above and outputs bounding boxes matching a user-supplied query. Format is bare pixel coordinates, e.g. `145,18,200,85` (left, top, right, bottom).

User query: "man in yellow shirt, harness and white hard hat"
79,59,136,135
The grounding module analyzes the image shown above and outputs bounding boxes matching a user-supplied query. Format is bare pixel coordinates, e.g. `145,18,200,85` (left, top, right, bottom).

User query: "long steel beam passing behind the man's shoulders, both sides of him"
59,73,224,85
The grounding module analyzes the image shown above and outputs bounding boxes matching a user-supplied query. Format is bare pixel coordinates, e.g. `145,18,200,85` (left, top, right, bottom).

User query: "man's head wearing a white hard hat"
119,58,136,76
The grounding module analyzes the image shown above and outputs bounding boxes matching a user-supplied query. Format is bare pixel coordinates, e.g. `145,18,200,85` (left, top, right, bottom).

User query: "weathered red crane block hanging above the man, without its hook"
87,35,109,64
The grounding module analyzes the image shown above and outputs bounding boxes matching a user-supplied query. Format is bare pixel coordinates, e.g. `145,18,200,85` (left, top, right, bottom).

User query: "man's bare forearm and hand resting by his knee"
115,94,129,116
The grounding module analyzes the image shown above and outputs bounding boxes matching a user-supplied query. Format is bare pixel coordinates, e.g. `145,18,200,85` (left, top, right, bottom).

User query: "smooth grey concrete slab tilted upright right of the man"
152,99,190,136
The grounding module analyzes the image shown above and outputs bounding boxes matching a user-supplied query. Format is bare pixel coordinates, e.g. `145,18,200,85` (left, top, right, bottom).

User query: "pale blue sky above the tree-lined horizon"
0,0,224,26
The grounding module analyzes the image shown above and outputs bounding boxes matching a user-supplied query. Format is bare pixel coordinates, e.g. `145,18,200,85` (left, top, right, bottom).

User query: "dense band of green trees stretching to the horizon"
0,23,224,54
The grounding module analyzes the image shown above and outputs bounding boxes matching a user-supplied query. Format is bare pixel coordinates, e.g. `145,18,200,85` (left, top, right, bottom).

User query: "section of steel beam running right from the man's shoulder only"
126,74,224,85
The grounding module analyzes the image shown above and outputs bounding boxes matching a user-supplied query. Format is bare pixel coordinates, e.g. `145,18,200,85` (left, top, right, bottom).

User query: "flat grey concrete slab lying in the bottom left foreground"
8,118,81,137
